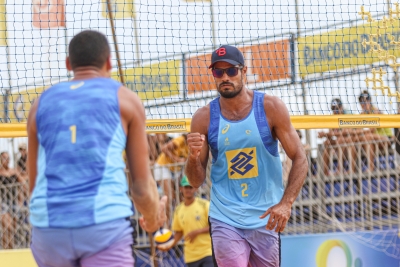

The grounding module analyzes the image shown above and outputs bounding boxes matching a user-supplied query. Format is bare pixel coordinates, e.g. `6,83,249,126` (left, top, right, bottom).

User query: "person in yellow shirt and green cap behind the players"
158,176,214,267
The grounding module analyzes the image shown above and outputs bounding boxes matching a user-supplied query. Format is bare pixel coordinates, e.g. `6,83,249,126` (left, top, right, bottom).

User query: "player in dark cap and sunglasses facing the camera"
185,45,308,267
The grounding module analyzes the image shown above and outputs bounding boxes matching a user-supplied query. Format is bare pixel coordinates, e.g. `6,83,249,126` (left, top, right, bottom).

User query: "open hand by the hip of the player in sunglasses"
260,202,292,233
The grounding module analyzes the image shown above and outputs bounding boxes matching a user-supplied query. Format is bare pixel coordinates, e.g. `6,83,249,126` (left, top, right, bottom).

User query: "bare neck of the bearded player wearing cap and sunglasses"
219,87,254,120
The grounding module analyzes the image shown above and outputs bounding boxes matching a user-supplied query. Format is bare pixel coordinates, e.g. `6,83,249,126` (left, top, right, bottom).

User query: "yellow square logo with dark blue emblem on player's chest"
225,147,258,179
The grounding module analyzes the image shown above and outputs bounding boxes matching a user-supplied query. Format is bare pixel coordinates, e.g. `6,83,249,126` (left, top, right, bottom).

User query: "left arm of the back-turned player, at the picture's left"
27,98,39,194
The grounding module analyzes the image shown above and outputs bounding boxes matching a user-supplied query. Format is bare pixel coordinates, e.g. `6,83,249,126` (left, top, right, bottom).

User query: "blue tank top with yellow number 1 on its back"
30,78,133,228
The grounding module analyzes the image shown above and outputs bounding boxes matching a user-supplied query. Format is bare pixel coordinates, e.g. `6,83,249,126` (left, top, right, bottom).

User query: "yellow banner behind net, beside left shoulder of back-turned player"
7,87,47,122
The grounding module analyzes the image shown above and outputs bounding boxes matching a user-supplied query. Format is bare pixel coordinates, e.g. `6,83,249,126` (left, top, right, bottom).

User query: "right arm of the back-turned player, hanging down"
118,87,160,232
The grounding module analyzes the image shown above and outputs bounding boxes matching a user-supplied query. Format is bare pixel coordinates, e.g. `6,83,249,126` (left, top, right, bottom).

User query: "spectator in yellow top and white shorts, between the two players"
154,134,189,225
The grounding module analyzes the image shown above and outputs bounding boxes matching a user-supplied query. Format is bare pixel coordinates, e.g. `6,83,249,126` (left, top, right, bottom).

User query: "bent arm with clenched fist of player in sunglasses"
185,106,210,188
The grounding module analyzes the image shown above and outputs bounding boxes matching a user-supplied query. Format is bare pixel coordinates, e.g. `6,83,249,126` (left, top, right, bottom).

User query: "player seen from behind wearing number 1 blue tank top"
28,31,166,267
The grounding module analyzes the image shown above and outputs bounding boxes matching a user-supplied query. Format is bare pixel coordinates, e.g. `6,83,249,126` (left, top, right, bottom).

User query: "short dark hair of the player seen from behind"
68,30,110,69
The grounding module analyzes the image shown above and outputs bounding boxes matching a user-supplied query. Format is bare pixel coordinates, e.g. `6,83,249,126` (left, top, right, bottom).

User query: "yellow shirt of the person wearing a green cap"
172,198,212,263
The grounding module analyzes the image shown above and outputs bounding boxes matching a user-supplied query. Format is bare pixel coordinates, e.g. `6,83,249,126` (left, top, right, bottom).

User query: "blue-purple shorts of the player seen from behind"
31,219,134,267
